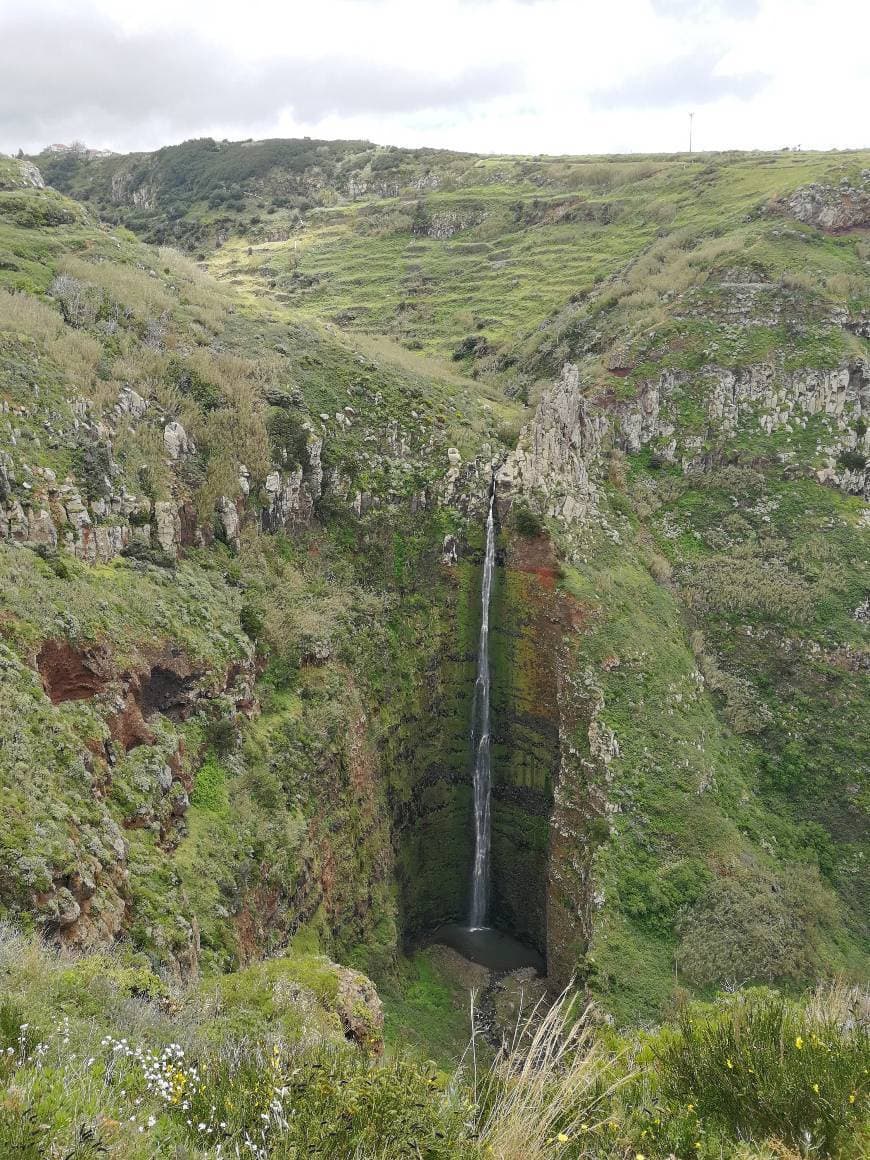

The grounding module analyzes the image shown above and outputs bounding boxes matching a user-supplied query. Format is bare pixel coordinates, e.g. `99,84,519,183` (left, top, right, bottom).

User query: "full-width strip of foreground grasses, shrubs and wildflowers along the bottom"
0,927,870,1160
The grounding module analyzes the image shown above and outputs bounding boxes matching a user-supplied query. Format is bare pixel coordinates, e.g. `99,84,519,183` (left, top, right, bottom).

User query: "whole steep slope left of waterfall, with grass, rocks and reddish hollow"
0,164,524,997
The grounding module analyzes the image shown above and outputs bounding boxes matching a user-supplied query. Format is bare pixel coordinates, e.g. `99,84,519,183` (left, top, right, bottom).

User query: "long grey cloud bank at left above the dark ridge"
0,9,521,144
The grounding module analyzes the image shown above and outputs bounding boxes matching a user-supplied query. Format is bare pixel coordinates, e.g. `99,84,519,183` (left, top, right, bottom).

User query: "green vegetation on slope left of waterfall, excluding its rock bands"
0,169,516,988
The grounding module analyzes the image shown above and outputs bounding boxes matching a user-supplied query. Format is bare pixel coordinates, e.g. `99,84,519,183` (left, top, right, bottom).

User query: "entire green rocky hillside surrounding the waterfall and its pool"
0,139,870,1160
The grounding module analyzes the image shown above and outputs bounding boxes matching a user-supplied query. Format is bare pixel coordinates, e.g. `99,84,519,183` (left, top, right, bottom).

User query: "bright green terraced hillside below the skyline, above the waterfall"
216,154,867,366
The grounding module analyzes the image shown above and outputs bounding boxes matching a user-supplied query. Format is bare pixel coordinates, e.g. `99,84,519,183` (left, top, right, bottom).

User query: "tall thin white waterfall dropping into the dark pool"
469,483,495,930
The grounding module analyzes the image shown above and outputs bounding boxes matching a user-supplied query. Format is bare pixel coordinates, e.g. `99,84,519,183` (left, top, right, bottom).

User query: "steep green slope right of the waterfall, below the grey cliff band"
563,467,868,1020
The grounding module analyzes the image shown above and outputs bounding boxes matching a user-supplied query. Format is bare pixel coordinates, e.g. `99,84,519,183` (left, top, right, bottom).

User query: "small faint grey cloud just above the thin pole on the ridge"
590,50,770,109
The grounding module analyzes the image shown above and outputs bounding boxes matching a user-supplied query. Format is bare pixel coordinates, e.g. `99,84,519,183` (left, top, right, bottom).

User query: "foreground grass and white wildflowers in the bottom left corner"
0,927,467,1160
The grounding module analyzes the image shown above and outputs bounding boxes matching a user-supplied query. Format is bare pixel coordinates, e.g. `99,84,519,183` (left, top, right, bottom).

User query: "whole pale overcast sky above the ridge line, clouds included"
0,0,870,153
